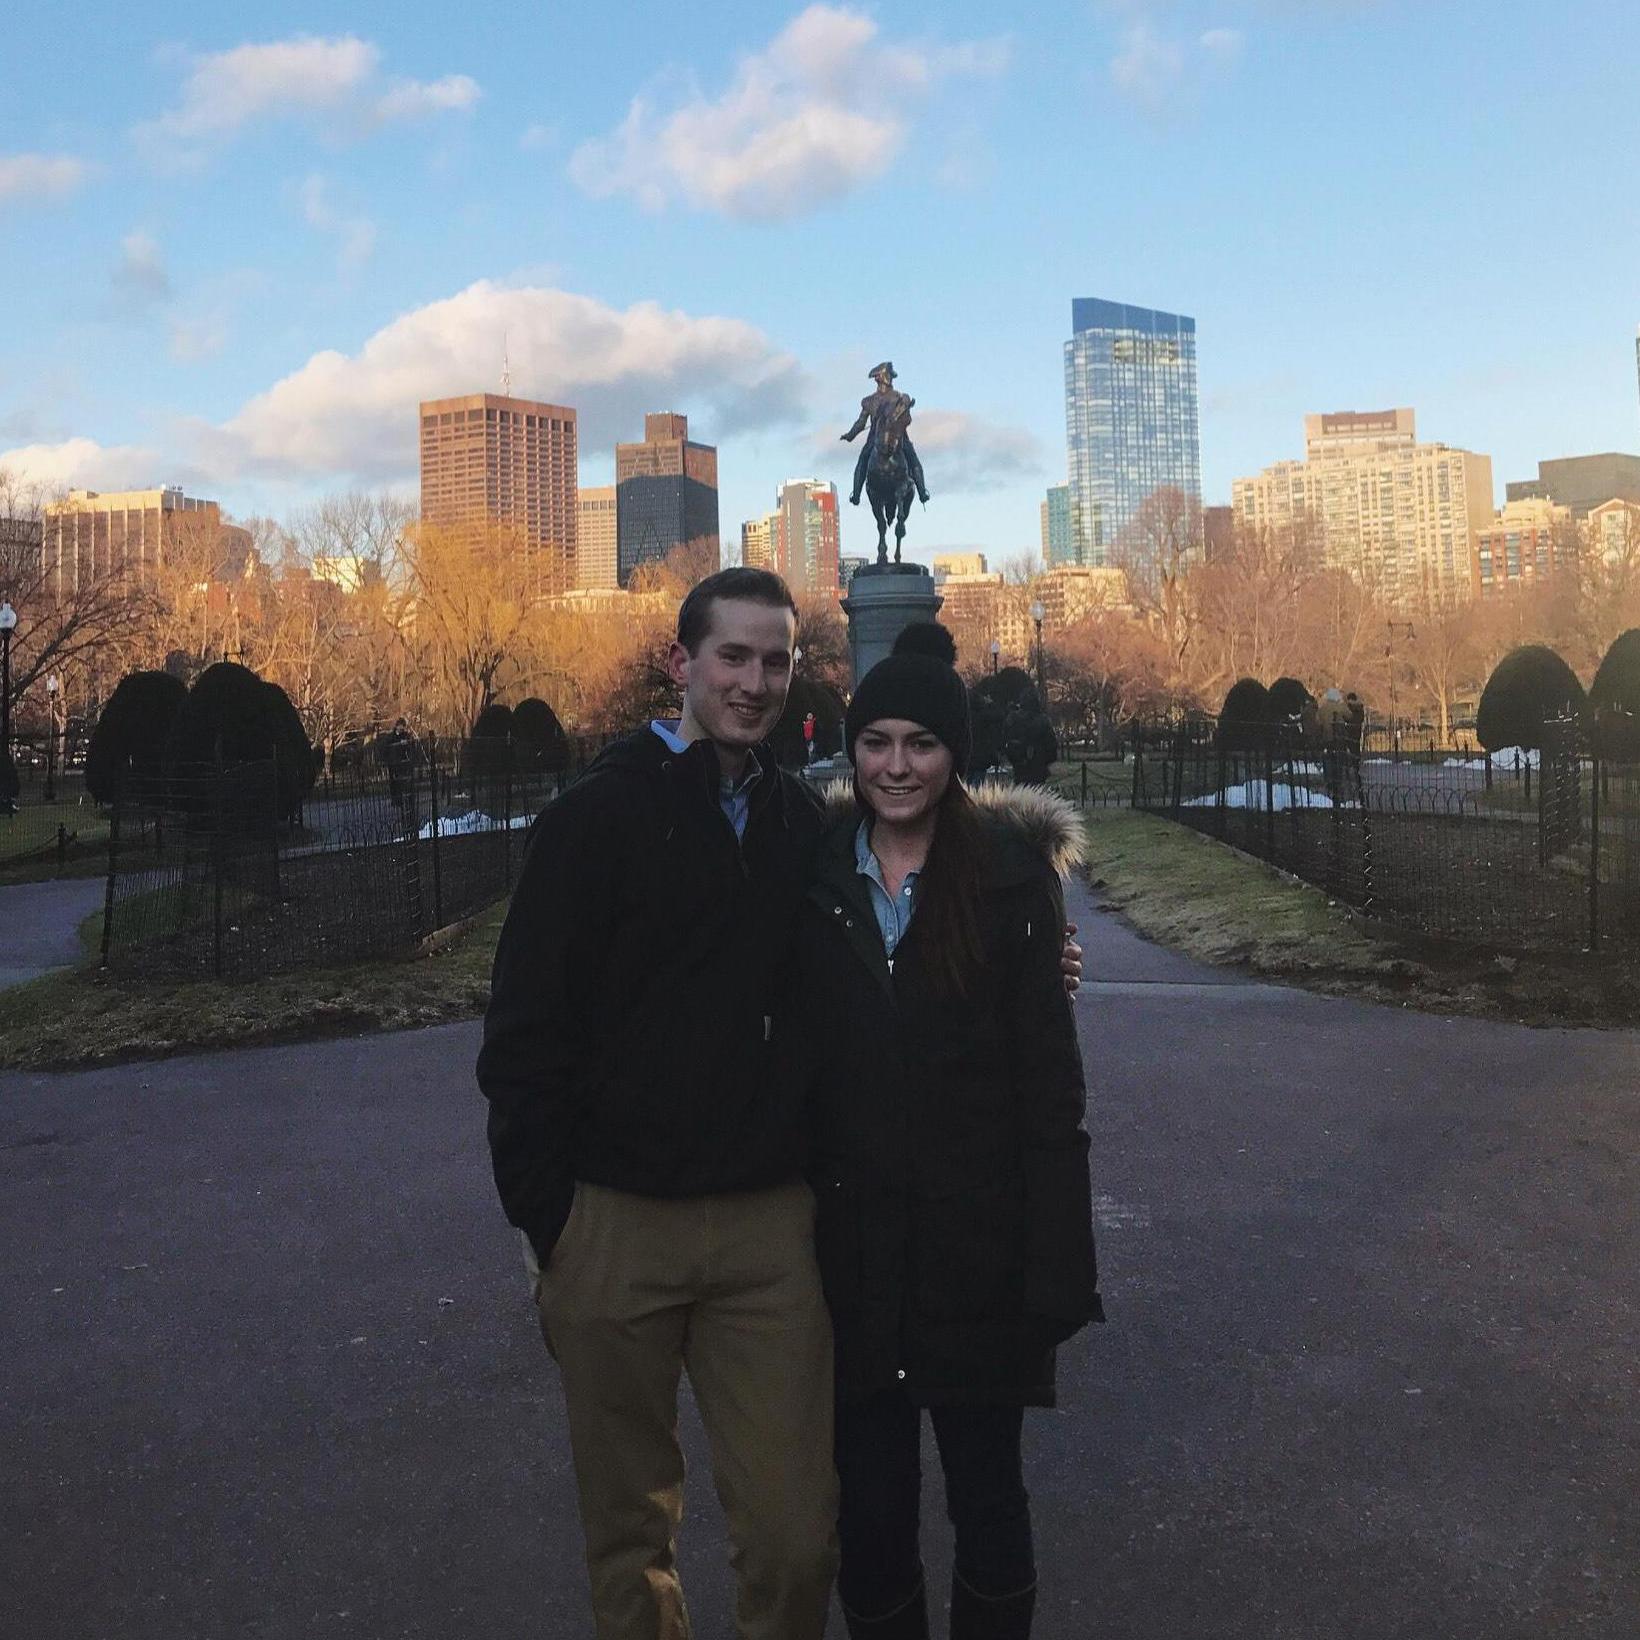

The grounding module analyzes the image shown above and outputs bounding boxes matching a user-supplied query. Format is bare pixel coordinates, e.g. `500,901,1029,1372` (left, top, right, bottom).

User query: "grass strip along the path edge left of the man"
0,905,507,1071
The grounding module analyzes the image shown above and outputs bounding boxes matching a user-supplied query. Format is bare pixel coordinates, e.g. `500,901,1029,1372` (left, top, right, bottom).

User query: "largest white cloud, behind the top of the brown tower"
208,280,804,482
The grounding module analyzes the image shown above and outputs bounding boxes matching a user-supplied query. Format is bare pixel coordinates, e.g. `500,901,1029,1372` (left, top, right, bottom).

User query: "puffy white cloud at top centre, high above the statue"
569,5,1009,220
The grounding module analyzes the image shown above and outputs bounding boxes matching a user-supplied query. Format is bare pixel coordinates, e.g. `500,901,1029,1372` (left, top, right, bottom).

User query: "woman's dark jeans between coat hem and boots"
836,1389,1036,1617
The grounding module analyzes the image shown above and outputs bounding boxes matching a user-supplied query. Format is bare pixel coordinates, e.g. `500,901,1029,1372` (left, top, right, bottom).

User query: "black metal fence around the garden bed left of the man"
102,741,603,979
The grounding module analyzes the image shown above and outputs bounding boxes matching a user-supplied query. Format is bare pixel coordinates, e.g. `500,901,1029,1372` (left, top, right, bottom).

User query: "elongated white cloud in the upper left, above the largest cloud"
138,34,481,157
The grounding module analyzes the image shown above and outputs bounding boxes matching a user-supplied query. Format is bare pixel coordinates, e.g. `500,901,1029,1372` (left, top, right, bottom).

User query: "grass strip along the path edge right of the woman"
1087,809,1640,1025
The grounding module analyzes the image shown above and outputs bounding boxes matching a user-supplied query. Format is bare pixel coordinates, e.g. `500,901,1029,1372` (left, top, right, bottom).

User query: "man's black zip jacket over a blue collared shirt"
479,730,822,1261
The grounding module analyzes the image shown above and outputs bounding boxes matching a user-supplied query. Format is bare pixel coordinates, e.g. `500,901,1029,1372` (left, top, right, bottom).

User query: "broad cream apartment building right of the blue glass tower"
1232,410,1492,605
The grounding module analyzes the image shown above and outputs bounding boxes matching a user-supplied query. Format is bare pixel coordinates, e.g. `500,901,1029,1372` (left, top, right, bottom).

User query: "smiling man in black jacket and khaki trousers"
479,569,836,1640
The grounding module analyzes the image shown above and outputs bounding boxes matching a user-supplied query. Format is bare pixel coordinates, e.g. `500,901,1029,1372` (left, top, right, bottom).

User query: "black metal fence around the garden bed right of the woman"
1132,720,1640,950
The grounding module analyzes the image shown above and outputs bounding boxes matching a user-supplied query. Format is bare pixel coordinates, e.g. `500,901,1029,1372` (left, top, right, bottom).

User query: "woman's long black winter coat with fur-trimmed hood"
799,787,1104,1405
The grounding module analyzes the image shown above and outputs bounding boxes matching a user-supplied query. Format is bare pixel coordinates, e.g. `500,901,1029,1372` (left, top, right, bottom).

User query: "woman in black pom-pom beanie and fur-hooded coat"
800,654,1104,1640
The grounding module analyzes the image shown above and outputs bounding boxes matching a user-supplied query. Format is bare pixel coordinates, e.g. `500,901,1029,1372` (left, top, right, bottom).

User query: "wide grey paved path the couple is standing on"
0,905,1640,1640
